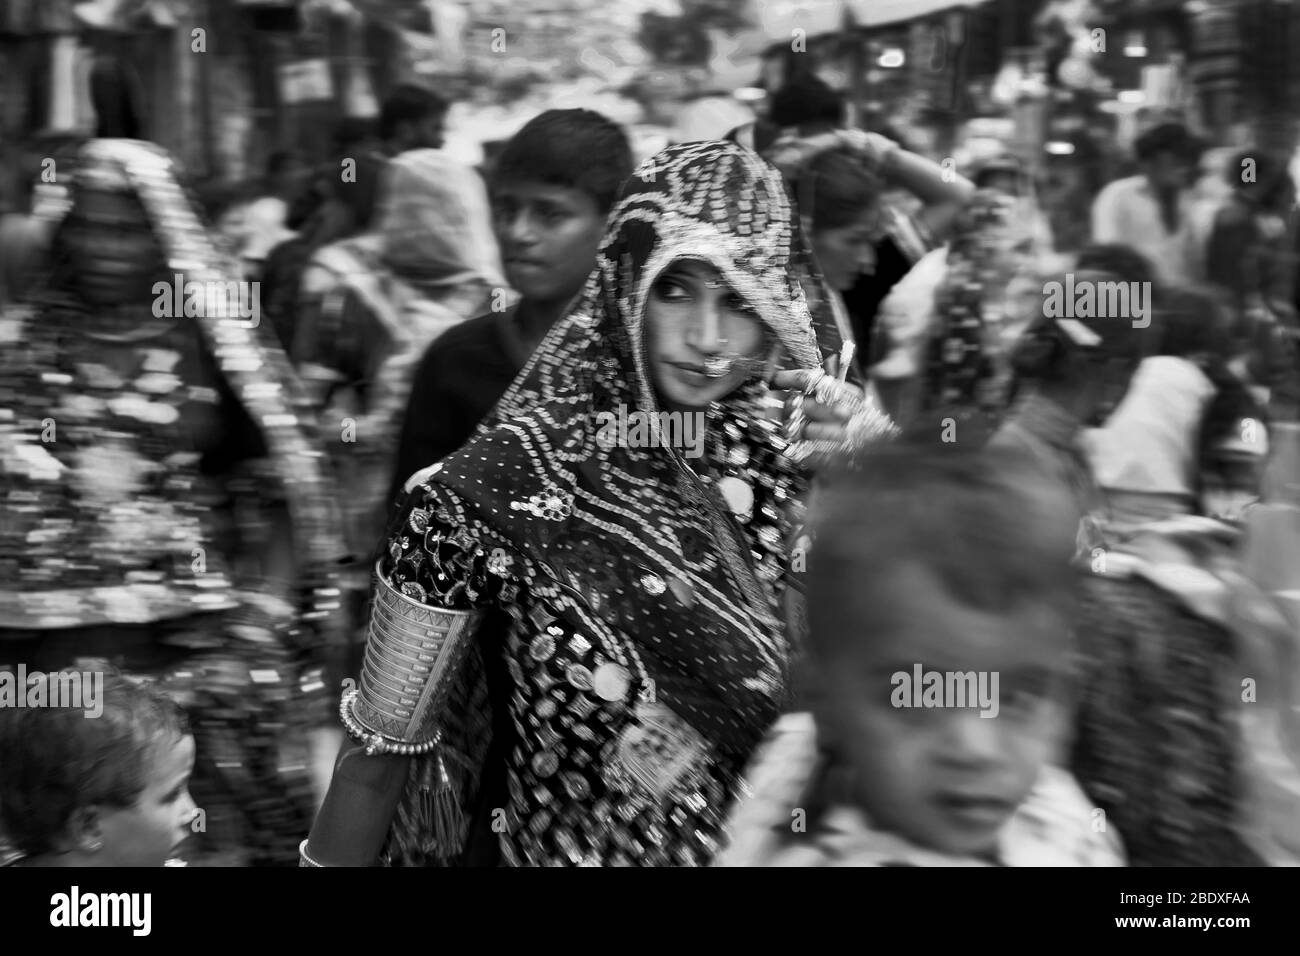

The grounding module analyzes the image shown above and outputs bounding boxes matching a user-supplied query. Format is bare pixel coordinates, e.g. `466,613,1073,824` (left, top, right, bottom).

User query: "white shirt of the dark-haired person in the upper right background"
1092,176,1200,282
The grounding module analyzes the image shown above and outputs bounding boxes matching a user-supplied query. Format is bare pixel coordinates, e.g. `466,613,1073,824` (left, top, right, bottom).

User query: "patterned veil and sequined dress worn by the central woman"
372,143,840,865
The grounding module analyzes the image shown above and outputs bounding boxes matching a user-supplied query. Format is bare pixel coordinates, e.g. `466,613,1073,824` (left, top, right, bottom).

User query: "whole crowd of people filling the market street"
0,79,1300,866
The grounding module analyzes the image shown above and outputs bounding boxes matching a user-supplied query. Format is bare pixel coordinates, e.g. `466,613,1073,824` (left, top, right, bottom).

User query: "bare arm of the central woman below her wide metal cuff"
307,740,411,866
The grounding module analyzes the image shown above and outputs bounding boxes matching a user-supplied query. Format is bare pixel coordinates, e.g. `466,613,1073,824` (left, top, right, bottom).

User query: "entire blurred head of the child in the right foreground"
809,445,1076,855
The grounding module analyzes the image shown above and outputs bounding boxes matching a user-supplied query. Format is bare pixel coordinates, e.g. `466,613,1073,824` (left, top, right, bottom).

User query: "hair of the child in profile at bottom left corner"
0,662,190,856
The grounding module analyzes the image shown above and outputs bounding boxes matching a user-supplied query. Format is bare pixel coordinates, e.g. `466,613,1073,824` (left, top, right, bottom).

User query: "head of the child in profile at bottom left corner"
0,674,195,866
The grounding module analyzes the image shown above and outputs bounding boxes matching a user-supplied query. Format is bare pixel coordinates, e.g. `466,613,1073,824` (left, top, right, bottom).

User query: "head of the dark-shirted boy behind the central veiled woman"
491,109,633,308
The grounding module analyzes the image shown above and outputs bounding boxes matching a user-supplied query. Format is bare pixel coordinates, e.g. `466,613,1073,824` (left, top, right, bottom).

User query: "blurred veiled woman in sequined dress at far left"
0,139,343,862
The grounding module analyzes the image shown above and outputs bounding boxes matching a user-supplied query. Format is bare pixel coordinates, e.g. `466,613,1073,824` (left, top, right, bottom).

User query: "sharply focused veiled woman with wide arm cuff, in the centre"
303,143,891,865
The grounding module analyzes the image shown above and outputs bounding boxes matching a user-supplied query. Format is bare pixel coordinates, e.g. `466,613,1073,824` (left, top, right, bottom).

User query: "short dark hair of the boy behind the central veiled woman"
493,109,634,215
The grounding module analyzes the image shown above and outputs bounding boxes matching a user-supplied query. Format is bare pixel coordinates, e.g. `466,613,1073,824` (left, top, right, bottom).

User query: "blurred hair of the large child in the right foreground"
807,440,1078,659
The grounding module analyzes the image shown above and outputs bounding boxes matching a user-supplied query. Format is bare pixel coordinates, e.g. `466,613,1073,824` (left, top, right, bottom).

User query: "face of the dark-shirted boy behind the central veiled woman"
493,181,605,302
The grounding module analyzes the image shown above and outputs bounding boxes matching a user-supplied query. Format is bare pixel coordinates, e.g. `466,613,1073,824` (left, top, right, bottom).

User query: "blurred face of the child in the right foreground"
818,564,1067,856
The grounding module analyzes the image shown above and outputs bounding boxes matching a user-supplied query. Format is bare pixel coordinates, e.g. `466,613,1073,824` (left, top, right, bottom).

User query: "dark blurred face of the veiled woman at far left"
64,190,164,306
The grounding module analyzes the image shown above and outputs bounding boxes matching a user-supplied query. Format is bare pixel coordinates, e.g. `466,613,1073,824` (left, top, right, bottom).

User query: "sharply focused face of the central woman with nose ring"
645,260,767,408
